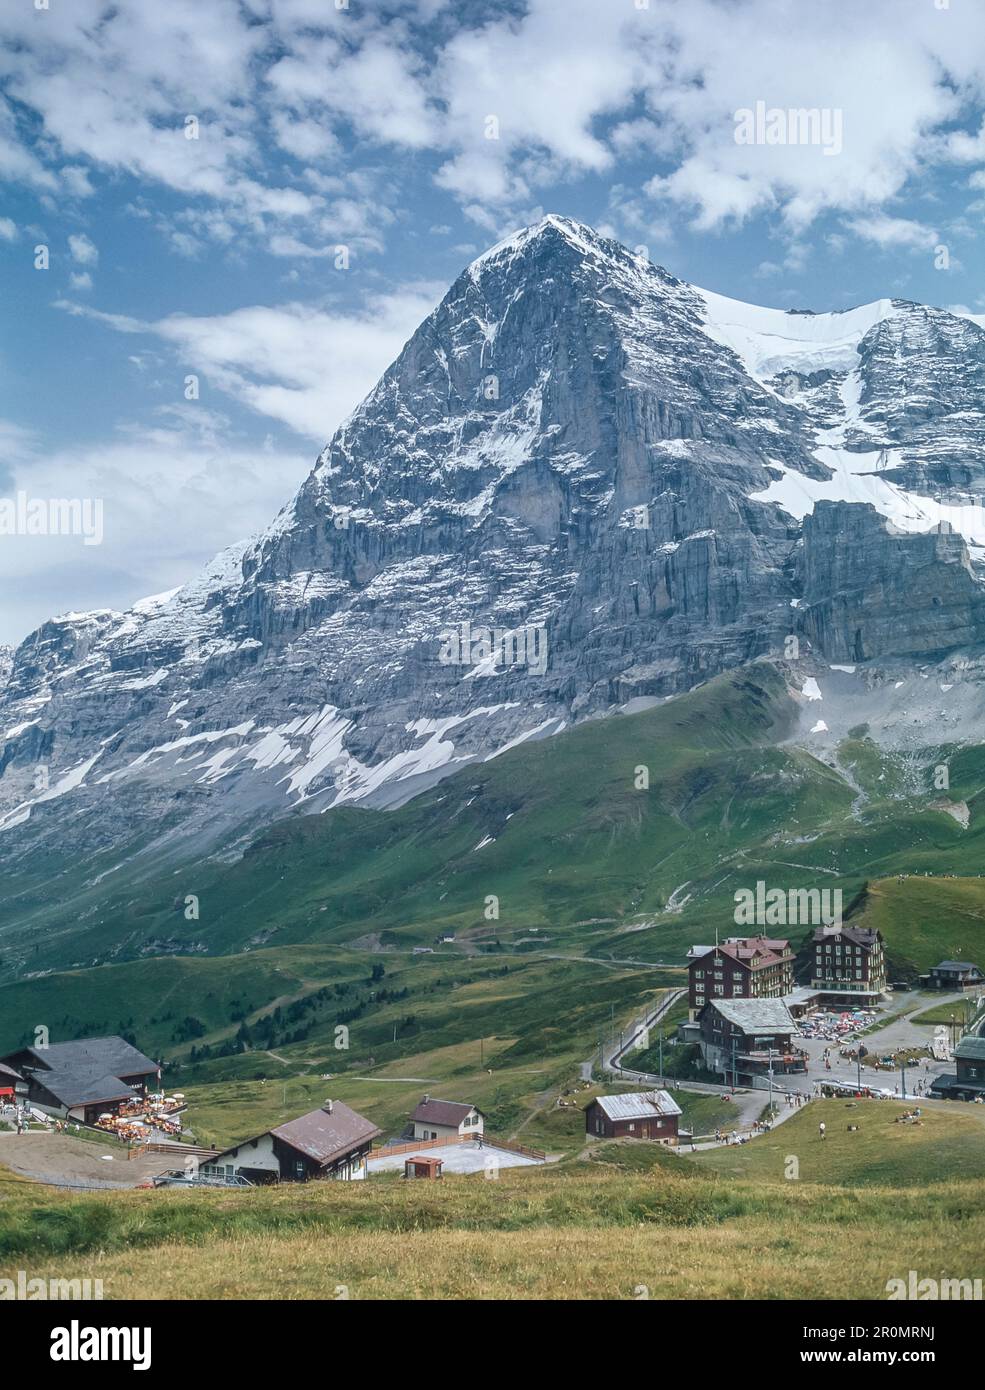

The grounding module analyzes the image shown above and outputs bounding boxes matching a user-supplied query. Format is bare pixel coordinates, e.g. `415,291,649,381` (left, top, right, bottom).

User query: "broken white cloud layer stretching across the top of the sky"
0,0,985,256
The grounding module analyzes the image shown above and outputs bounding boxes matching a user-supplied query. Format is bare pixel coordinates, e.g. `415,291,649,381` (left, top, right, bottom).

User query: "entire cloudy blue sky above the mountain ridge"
0,0,985,642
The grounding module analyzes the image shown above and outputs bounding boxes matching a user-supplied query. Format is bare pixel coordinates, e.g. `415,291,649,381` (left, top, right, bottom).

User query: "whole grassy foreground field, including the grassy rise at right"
0,1102,985,1300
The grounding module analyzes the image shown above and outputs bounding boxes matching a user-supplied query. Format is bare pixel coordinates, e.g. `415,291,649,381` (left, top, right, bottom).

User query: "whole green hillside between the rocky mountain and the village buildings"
0,663,985,1080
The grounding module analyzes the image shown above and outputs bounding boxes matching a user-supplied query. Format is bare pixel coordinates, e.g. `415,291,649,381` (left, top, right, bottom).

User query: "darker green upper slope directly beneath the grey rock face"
0,664,853,977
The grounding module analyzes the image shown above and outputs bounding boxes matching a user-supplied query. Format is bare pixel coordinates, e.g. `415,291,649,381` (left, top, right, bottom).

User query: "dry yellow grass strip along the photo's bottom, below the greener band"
9,1213,985,1300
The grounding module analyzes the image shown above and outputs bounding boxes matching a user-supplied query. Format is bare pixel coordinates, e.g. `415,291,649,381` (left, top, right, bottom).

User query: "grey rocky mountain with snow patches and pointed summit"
0,217,985,880
